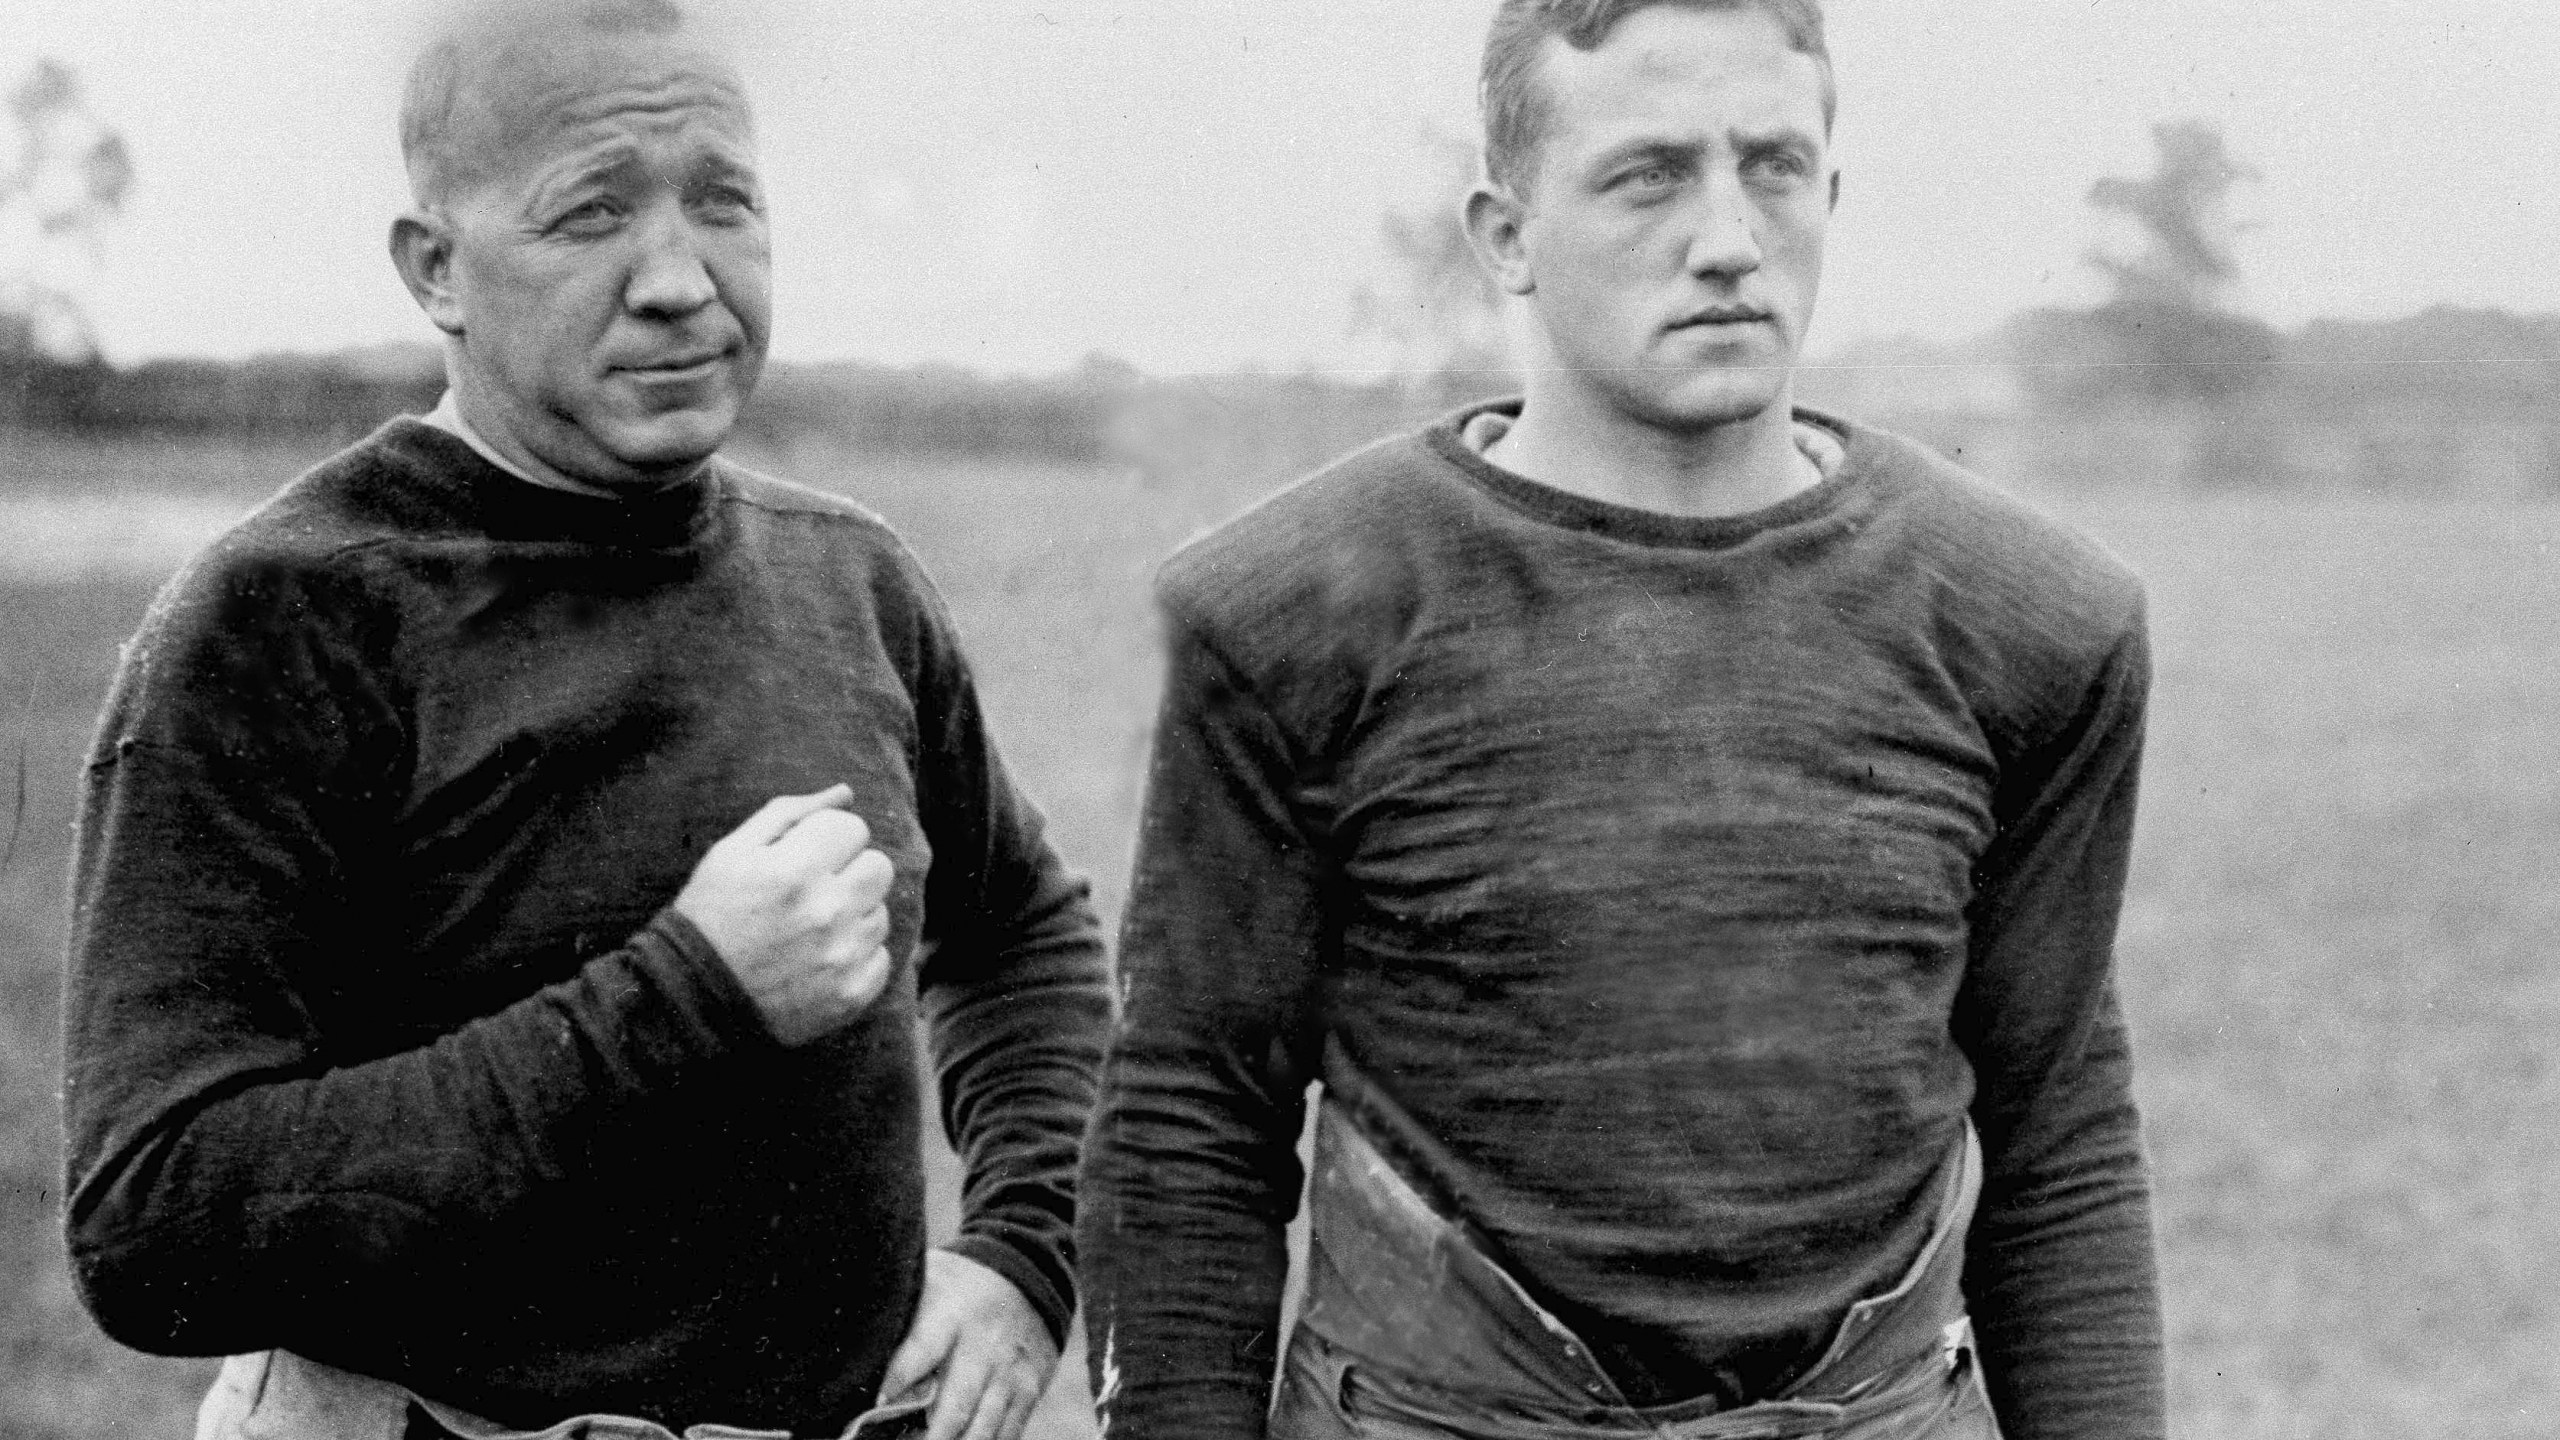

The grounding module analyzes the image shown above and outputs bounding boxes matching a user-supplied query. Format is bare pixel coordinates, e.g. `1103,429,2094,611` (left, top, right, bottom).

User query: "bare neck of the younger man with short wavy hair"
1485,384,1823,518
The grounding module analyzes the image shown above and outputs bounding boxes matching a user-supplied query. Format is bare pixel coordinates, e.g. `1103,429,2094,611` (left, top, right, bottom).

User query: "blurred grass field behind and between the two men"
0,422,2560,1440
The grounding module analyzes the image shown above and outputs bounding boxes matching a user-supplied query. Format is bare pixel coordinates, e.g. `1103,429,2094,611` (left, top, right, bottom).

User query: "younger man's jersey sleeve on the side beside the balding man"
1083,607,1331,1440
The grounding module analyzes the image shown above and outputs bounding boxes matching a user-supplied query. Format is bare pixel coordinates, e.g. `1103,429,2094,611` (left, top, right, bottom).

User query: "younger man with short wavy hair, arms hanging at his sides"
1080,0,2163,1440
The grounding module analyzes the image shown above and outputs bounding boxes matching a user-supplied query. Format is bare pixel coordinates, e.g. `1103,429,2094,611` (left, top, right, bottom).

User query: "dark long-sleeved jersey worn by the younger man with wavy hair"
1083,399,2163,1440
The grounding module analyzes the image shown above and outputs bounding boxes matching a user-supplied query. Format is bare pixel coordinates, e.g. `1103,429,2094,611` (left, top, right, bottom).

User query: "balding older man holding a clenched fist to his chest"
67,0,1106,1440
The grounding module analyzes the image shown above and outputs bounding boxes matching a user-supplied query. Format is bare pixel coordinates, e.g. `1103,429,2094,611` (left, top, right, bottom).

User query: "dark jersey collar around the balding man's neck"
384,415,722,551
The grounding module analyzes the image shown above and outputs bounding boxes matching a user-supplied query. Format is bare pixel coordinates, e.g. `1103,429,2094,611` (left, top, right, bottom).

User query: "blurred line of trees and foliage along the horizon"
0,95,2560,500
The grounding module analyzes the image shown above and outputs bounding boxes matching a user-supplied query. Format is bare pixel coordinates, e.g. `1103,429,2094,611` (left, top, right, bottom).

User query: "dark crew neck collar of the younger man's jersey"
1423,397,1866,551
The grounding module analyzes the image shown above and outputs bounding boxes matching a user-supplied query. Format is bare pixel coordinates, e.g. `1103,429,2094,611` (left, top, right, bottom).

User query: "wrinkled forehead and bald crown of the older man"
430,20,755,198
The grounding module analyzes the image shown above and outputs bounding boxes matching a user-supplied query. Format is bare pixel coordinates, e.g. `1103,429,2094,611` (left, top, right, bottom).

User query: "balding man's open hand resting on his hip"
881,1250,1057,1440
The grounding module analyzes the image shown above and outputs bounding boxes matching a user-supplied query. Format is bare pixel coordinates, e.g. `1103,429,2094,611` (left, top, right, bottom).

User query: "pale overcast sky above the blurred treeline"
0,0,2560,374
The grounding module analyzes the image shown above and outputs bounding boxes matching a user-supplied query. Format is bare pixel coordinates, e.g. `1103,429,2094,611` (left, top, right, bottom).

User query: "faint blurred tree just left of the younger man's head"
1352,126,1516,397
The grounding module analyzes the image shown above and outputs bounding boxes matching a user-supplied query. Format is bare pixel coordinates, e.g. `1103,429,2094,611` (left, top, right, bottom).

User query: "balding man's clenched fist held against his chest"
676,784,896,1045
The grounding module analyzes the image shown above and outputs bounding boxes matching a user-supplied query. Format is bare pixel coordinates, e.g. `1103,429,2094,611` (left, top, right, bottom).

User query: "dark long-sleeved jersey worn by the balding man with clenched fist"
67,420,1108,1432
